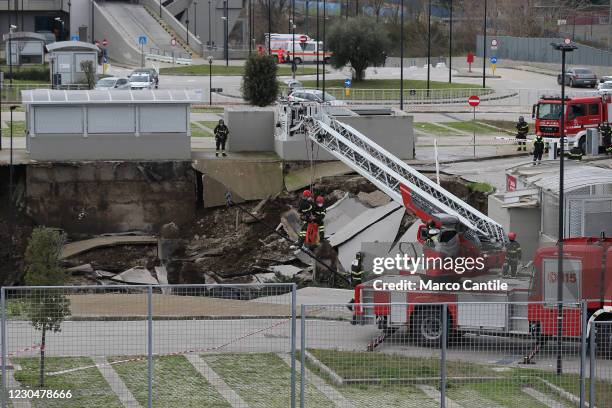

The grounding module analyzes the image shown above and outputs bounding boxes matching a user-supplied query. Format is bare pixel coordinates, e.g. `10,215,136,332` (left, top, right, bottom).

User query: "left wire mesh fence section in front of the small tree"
2,284,296,407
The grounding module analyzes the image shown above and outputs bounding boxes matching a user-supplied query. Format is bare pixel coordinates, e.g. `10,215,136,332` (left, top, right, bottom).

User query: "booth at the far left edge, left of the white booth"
2,31,45,65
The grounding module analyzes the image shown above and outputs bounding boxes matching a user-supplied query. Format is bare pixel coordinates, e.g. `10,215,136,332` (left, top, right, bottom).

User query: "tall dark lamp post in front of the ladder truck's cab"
551,38,578,375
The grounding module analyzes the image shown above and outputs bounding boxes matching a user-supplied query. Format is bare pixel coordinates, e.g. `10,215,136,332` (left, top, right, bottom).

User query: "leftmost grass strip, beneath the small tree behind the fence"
14,357,122,408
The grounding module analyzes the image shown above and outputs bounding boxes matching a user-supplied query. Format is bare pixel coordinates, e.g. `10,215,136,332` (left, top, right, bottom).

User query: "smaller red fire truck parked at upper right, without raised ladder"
531,94,612,153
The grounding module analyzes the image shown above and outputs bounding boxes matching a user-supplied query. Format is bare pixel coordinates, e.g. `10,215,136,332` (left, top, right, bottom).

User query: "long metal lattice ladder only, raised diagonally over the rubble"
302,106,506,246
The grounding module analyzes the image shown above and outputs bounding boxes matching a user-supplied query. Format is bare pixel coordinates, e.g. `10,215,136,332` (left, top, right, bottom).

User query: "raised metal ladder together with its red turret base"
292,104,507,276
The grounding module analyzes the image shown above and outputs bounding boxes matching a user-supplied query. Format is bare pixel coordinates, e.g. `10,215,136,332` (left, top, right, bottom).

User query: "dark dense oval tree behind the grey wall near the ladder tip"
242,54,278,106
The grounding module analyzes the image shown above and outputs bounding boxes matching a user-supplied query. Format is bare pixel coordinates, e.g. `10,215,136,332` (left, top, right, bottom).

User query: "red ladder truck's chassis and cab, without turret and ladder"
353,238,612,345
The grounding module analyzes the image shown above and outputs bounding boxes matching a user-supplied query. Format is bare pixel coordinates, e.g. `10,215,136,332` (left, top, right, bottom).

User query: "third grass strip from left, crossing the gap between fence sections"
201,353,334,408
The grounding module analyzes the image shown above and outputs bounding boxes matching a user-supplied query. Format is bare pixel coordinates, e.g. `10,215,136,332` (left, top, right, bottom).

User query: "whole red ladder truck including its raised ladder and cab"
284,104,612,357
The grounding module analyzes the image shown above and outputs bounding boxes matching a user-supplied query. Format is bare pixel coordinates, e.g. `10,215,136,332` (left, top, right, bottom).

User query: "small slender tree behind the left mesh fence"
24,227,70,387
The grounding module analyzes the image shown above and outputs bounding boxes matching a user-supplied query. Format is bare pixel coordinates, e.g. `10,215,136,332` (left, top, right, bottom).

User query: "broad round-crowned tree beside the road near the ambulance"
327,17,390,81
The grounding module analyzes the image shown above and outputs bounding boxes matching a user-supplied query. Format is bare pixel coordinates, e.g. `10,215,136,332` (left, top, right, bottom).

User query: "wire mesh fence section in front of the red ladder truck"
299,302,612,408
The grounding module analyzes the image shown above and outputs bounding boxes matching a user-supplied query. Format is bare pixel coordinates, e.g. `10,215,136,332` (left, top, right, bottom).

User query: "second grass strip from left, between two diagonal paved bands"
109,356,230,408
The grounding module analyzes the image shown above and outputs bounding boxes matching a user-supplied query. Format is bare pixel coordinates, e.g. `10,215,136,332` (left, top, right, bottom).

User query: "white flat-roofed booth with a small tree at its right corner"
47,41,100,85
